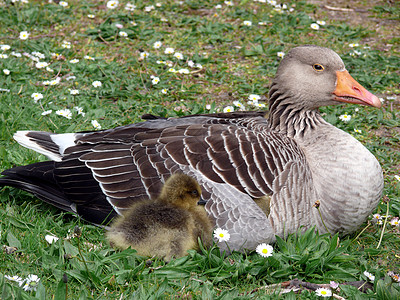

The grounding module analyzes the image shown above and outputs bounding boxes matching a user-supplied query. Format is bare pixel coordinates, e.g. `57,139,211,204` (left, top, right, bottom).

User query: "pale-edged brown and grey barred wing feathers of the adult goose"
59,116,309,250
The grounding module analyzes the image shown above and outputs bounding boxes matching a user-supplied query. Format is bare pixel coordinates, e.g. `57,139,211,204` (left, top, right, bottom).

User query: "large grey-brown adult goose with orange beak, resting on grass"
0,46,383,250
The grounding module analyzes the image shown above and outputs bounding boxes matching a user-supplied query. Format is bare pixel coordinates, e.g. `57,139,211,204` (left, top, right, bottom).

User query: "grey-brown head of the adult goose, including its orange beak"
270,45,381,111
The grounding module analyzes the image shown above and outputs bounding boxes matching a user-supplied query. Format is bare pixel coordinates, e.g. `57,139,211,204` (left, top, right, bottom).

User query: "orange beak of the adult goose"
333,70,382,108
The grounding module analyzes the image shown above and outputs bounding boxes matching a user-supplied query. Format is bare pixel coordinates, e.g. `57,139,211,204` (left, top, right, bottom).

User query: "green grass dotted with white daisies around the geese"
0,0,400,299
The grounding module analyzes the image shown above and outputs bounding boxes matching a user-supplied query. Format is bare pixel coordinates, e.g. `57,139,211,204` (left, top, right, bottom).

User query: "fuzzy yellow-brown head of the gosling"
159,173,201,208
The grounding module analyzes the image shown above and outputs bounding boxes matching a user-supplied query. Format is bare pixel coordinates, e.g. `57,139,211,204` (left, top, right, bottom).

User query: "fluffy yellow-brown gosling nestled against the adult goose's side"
106,173,213,261
